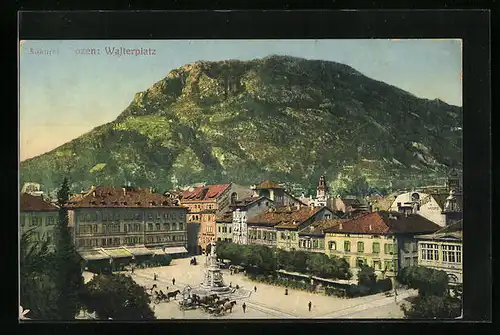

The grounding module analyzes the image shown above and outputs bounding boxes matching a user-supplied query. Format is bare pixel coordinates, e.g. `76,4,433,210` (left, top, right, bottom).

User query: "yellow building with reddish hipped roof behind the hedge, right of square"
324,211,440,277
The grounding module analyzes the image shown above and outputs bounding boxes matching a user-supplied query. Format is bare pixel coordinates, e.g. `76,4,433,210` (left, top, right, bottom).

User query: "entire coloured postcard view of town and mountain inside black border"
18,35,466,322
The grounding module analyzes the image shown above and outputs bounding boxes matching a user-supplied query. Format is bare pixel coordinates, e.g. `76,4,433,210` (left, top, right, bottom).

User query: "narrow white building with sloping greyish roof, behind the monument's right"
231,197,274,244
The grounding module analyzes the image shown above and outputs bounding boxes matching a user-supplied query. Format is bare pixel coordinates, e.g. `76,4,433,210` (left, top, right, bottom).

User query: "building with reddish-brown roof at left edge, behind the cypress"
19,193,59,251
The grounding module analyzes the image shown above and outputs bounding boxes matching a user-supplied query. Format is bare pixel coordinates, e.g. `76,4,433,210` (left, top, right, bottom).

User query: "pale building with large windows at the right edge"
417,221,463,285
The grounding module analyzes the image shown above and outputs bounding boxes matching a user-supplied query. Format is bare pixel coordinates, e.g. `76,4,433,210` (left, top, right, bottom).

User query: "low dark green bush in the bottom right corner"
401,295,462,319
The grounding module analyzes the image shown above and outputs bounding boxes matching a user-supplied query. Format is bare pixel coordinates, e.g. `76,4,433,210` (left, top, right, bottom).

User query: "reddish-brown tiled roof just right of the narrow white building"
247,206,325,228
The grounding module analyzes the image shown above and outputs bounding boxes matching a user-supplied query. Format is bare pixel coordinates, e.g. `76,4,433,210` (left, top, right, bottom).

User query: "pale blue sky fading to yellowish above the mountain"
19,39,462,161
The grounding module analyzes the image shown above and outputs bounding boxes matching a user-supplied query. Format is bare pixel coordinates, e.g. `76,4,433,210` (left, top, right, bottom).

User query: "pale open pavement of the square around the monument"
101,256,417,319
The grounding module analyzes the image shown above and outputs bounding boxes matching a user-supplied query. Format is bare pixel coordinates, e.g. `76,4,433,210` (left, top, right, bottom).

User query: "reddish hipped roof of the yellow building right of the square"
325,211,441,235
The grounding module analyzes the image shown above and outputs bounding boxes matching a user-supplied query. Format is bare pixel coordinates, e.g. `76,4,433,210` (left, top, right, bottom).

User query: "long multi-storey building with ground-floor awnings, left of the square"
67,187,187,260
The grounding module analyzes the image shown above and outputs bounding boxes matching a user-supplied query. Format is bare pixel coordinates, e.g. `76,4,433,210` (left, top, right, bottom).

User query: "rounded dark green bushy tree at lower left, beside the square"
82,274,156,320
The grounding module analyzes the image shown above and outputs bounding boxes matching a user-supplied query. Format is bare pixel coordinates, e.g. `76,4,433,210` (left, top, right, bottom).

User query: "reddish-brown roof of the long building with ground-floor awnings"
67,186,179,208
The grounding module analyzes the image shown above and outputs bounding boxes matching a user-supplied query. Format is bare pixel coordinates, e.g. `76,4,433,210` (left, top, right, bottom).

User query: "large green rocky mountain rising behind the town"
21,55,462,191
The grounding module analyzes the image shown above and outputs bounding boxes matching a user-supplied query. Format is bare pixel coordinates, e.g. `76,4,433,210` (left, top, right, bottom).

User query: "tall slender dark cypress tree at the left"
54,178,83,320
